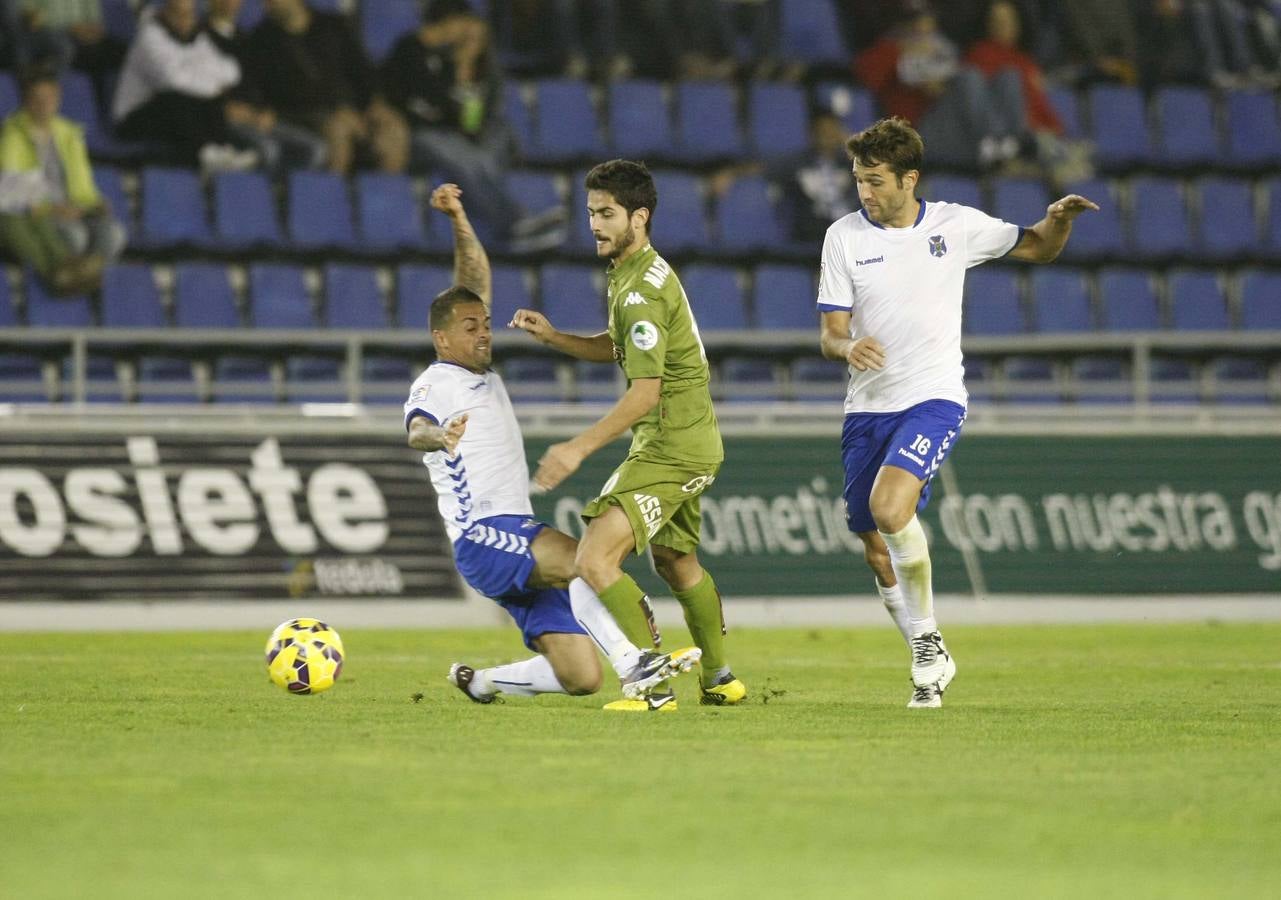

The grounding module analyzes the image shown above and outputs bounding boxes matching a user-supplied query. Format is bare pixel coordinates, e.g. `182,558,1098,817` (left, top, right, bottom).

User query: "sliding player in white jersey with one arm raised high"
405,184,701,703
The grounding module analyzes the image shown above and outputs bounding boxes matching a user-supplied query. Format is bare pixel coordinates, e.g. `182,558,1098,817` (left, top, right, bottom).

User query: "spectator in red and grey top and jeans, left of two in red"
854,1,1027,168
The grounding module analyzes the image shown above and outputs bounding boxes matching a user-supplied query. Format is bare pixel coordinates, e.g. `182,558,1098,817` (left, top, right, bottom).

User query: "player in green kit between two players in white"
511,160,747,712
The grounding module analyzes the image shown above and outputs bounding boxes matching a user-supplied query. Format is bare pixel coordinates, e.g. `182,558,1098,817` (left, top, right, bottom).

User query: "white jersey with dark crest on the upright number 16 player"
819,200,1024,412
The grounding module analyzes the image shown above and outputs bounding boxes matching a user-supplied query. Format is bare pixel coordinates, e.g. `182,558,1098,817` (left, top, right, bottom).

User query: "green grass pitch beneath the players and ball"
0,622,1281,900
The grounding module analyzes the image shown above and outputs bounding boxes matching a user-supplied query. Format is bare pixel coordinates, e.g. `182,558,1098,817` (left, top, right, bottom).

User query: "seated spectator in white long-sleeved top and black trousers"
111,0,257,170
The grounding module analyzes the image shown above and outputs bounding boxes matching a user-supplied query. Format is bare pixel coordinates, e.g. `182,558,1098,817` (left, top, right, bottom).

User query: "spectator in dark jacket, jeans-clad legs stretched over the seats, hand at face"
382,0,565,251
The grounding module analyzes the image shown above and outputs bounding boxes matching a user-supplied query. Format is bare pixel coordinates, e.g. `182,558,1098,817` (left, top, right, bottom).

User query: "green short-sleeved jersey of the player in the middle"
608,245,725,463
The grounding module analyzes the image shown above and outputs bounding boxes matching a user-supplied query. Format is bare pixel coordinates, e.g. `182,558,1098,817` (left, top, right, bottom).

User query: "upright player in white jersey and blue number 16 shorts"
819,118,1098,707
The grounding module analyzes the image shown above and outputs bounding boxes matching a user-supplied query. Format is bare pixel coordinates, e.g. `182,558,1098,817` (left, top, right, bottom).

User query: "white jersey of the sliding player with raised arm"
405,362,534,543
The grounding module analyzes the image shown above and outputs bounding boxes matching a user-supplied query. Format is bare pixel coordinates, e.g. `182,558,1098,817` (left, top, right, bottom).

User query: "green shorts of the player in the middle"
583,460,720,553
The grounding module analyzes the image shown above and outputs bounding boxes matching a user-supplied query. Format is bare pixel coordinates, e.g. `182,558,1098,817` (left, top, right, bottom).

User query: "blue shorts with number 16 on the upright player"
840,399,965,533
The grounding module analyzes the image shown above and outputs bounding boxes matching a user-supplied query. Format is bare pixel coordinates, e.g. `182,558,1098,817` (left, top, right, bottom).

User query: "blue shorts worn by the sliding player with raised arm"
453,516,587,650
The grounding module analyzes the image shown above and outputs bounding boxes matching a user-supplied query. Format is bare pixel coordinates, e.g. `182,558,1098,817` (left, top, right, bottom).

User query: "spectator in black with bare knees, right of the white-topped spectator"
236,0,409,174
